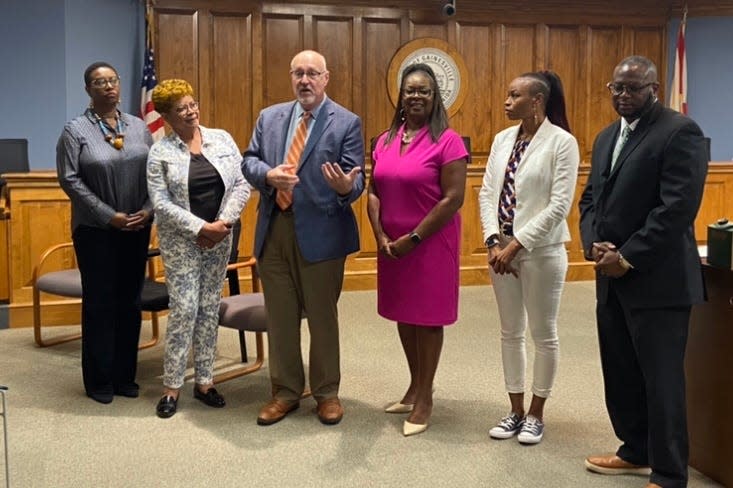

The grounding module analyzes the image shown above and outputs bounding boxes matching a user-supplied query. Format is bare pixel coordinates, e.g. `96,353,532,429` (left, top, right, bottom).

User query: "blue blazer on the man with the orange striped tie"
242,98,364,262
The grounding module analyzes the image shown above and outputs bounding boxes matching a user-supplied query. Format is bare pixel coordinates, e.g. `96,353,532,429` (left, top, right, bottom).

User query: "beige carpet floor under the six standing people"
0,282,720,488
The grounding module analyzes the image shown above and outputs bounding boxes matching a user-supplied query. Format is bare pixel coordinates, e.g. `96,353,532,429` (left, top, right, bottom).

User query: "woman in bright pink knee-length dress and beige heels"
368,64,468,436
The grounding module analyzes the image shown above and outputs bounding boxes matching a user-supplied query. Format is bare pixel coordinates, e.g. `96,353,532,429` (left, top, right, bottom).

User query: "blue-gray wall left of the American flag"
0,0,144,169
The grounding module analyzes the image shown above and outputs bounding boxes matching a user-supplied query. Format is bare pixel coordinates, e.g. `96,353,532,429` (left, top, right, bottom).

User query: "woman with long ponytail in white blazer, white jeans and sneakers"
479,71,580,444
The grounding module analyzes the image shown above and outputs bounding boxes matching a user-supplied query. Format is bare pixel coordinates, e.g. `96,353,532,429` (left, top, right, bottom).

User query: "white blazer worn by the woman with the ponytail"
478,118,580,252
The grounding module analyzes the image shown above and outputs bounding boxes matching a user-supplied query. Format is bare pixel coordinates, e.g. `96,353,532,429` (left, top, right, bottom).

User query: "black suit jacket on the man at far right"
579,102,708,308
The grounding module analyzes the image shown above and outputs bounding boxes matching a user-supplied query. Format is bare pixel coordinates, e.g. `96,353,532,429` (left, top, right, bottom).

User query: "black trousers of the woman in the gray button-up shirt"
72,226,150,393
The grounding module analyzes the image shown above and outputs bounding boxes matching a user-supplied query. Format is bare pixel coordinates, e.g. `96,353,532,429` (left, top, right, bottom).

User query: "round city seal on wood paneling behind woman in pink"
387,37,468,117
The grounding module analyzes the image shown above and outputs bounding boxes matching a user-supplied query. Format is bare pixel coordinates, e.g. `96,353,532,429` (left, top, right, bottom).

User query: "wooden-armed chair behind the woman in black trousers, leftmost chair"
31,242,168,349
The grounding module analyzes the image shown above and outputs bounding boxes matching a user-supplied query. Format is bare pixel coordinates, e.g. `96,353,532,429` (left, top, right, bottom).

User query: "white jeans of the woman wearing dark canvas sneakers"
489,242,568,398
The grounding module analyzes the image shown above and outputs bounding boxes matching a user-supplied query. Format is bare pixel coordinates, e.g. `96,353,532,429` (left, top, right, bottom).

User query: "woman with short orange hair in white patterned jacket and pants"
148,79,250,418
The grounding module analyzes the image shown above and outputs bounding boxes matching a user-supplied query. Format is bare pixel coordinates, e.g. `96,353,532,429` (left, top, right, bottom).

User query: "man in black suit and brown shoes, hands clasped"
580,56,708,488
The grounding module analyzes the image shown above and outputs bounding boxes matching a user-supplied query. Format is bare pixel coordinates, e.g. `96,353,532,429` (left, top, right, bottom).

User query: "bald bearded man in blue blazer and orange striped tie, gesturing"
242,51,364,425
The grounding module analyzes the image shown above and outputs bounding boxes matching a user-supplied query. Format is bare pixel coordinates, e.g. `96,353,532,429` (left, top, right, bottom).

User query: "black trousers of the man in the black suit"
596,285,691,488
